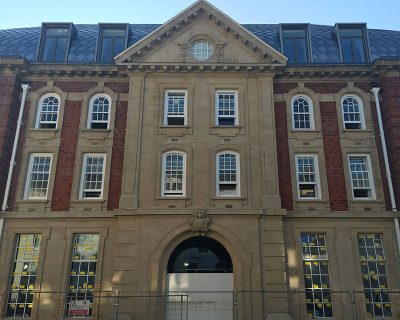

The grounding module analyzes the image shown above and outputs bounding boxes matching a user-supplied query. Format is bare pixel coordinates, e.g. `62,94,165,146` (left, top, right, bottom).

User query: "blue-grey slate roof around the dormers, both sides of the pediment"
0,24,400,64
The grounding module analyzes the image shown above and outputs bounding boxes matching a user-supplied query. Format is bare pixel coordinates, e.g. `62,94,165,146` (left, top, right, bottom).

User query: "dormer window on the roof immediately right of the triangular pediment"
281,26,310,64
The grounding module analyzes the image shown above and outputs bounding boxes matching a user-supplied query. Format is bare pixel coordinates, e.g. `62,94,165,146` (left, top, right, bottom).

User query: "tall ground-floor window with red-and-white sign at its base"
65,234,99,318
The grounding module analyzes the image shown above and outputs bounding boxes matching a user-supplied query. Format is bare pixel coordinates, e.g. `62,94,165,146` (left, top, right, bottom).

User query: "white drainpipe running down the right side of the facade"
371,87,400,259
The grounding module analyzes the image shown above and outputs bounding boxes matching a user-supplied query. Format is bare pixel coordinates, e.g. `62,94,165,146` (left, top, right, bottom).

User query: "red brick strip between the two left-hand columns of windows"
51,101,82,211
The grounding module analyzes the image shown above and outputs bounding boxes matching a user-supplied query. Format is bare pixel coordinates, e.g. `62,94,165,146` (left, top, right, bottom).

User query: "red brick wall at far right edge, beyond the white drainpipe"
380,77,400,207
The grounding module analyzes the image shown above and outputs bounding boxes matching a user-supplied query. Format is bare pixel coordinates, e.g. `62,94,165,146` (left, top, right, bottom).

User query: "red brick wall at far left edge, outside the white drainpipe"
0,75,22,203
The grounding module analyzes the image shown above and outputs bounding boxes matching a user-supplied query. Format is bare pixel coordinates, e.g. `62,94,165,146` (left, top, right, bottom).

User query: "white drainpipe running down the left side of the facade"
0,84,30,243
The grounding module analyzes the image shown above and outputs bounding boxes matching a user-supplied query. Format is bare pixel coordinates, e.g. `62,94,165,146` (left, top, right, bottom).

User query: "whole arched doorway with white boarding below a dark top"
167,237,233,320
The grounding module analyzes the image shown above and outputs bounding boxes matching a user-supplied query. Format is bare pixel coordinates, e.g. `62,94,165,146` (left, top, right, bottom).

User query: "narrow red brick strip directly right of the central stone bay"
275,102,293,210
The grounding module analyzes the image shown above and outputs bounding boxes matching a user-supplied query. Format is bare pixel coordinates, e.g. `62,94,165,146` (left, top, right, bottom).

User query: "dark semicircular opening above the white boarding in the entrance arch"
168,237,233,273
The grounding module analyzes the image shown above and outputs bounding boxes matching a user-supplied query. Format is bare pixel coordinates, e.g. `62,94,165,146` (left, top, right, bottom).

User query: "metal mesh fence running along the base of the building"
0,289,400,320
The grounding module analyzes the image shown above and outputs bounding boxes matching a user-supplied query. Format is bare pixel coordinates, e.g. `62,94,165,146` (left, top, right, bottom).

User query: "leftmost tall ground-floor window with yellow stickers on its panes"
5,234,42,319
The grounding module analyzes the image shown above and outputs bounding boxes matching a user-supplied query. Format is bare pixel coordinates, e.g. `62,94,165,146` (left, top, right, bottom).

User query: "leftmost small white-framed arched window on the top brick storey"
35,93,60,129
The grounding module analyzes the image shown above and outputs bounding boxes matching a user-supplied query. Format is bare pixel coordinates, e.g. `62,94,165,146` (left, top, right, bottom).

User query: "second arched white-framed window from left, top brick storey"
87,93,111,129
